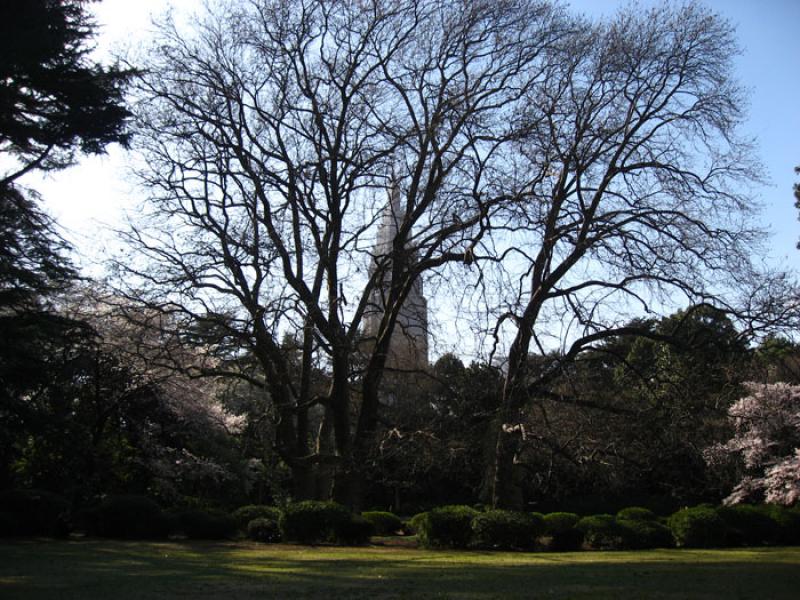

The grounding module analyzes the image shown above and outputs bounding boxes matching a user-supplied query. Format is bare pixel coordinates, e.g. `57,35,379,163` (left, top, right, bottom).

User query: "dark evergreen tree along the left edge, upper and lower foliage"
0,0,132,488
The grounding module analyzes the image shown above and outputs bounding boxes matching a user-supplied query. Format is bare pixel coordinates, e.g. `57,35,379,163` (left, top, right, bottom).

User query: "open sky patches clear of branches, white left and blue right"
29,0,800,274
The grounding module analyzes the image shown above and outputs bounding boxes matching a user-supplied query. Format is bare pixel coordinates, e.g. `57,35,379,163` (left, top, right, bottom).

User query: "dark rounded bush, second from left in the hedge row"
84,495,170,540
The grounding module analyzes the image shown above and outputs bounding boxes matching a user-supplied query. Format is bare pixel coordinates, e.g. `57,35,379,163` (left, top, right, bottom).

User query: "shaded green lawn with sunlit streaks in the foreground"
0,540,800,600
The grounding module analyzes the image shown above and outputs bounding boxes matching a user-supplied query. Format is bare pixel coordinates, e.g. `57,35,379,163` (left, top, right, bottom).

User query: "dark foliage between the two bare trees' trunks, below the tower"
367,354,502,514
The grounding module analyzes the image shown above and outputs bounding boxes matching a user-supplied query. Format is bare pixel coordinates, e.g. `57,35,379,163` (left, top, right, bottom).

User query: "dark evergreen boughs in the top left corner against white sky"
0,0,132,183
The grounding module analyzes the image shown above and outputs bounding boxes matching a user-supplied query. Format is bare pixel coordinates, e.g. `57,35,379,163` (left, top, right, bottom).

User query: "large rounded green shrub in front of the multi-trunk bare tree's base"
279,500,350,544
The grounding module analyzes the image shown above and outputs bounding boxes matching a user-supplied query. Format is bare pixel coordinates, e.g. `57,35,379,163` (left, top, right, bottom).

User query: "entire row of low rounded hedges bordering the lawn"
0,490,800,550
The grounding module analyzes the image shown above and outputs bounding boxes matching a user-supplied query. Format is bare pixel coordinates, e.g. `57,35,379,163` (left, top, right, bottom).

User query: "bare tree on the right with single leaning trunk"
478,4,796,506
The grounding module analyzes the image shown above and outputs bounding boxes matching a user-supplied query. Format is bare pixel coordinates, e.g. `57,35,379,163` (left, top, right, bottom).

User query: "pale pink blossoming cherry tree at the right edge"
706,383,800,505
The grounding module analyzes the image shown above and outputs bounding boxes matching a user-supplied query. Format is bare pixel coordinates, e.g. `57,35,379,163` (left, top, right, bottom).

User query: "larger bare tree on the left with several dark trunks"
119,0,571,505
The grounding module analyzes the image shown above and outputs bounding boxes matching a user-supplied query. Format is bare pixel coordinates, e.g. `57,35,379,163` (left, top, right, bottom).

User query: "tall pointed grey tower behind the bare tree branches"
364,177,428,371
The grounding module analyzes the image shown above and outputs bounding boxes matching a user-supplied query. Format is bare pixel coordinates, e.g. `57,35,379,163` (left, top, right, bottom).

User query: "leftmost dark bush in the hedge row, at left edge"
0,490,70,537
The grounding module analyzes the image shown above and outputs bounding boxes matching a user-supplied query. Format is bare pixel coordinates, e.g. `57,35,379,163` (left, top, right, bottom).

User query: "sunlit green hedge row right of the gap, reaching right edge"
409,505,800,551
